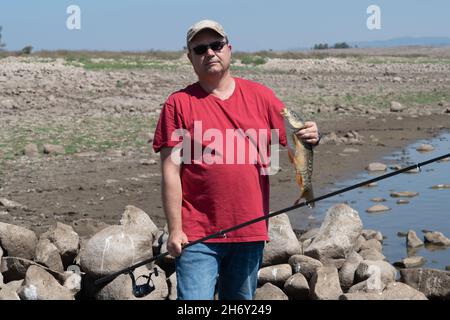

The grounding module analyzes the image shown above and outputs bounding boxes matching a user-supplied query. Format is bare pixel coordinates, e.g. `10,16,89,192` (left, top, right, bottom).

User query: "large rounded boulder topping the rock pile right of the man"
304,204,362,261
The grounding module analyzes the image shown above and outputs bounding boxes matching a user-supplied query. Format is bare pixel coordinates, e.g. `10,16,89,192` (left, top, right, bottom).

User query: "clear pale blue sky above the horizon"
0,0,450,51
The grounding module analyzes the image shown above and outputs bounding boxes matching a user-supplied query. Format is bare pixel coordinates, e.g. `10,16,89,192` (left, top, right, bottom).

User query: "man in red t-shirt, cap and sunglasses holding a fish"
153,20,319,300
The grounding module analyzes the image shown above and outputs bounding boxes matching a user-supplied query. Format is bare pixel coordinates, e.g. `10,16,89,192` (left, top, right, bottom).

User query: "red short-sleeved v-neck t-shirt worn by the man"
153,78,286,242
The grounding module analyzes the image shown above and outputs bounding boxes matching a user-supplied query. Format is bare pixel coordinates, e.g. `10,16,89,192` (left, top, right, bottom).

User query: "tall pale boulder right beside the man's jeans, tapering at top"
262,213,302,266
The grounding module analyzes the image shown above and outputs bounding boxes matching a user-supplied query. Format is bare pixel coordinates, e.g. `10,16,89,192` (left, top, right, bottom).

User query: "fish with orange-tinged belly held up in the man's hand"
280,107,314,207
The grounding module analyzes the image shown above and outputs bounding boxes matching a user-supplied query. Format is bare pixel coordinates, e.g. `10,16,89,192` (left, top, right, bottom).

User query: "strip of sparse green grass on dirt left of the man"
0,115,157,161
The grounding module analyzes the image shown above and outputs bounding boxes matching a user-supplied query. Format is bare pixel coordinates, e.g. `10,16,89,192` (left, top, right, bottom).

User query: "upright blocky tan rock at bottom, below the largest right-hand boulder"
310,267,342,300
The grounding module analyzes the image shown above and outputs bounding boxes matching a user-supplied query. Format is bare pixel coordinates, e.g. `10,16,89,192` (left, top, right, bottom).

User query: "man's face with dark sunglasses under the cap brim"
188,29,231,77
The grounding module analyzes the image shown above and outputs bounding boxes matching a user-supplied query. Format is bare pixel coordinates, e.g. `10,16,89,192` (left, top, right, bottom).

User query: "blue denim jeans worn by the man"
175,241,264,300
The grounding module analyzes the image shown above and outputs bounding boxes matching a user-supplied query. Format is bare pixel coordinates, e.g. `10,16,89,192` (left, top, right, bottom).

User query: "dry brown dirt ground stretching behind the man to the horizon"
0,50,450,237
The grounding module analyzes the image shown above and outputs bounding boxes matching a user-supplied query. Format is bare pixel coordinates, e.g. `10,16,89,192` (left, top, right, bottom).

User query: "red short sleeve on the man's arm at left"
153,102,183,152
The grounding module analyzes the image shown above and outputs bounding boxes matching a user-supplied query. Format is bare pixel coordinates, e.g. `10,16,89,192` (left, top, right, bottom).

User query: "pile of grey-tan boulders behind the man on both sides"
0,204,450,300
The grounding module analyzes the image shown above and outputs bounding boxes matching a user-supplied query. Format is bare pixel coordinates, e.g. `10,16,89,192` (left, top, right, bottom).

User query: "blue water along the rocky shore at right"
290,134,450,269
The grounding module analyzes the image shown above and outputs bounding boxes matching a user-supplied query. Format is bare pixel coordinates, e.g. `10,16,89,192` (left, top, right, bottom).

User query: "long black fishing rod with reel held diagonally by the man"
94,153,450,297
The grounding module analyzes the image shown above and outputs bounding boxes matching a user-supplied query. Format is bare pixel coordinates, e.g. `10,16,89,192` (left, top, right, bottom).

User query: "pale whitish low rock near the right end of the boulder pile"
355,260,397,284
